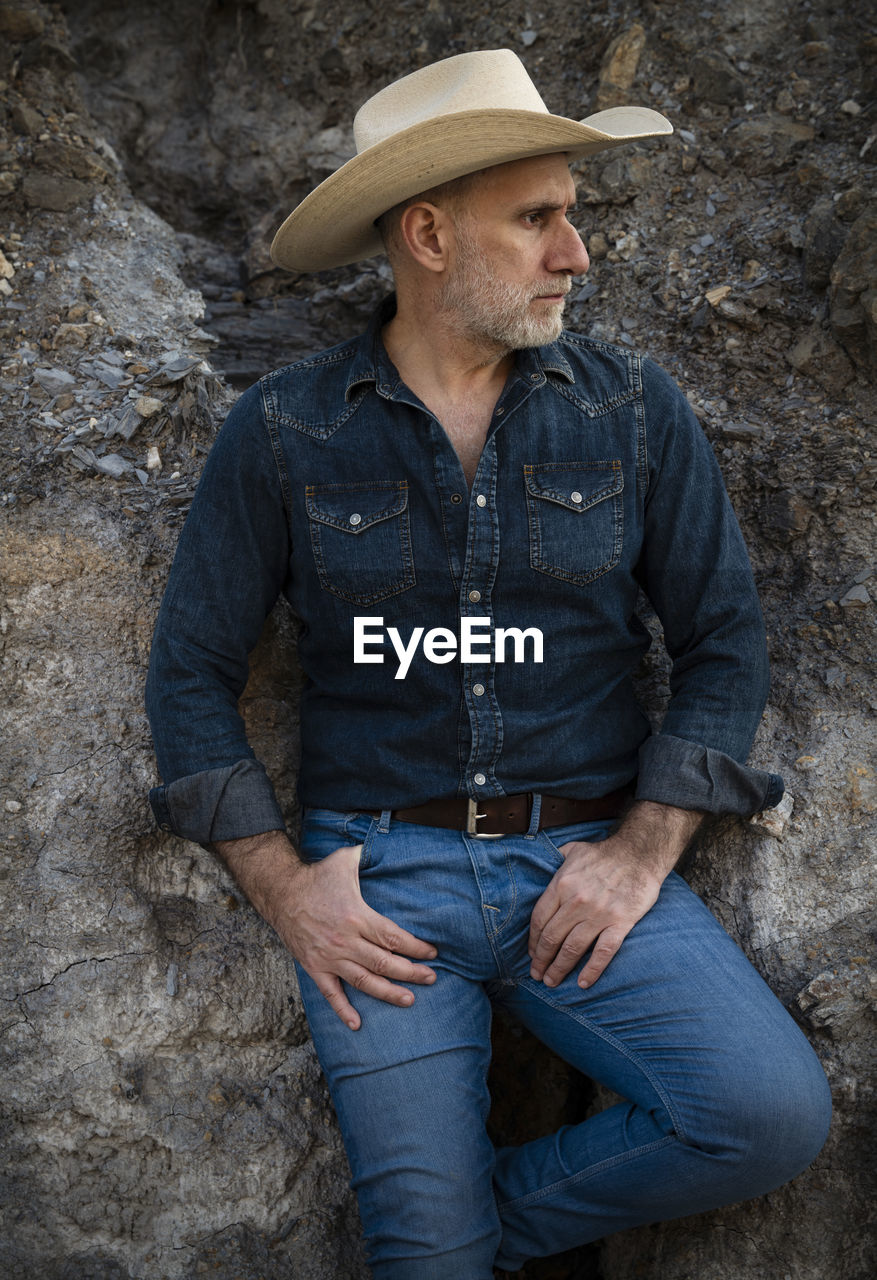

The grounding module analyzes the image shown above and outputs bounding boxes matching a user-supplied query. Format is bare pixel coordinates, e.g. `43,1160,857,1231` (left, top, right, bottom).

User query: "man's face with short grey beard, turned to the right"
438,155,589,351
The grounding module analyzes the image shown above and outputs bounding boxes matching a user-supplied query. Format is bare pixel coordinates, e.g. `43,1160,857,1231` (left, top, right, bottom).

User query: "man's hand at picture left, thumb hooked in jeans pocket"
212,832,437,1030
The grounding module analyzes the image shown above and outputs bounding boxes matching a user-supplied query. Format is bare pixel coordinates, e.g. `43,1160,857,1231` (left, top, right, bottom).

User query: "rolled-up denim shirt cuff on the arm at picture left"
150,760,287,845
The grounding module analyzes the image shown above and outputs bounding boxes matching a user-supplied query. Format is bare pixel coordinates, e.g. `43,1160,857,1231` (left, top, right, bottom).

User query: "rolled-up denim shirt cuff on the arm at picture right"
636,733,785,817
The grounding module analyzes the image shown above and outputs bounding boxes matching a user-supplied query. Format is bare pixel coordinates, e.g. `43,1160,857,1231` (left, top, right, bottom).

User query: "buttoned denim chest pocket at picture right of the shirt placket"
524,460,625,586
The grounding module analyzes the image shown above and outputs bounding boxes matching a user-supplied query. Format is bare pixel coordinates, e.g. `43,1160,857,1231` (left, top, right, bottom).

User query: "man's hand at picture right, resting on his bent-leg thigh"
529,801,700,988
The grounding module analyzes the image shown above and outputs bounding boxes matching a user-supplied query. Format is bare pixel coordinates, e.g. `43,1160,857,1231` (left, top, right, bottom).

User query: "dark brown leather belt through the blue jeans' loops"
361,786,632,836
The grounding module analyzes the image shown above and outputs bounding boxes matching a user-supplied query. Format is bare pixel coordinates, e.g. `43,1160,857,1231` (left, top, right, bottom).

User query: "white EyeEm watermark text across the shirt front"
353,617,543,680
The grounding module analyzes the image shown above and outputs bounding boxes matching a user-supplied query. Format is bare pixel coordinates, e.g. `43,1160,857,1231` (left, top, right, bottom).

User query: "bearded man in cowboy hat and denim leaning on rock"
149,50,828,1280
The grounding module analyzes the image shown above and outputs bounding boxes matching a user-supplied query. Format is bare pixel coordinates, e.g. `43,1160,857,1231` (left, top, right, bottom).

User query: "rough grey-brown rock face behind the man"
0,0,877,1280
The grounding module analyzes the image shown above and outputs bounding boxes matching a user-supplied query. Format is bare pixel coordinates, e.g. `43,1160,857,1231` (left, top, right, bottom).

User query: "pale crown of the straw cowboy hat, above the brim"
353,49,548,152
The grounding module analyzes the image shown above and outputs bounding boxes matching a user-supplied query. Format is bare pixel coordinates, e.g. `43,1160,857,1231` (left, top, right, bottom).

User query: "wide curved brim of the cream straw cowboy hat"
271,106,673,271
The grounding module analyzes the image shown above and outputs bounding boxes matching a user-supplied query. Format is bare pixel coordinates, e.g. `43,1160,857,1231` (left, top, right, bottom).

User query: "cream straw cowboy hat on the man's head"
271,49,673,271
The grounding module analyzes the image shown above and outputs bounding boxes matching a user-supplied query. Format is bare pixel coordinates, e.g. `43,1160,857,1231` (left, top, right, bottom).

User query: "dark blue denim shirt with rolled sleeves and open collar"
147,298,782,844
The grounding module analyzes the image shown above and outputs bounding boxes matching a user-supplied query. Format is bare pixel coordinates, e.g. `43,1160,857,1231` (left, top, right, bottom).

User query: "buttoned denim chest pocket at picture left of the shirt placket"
305,480,415,604
